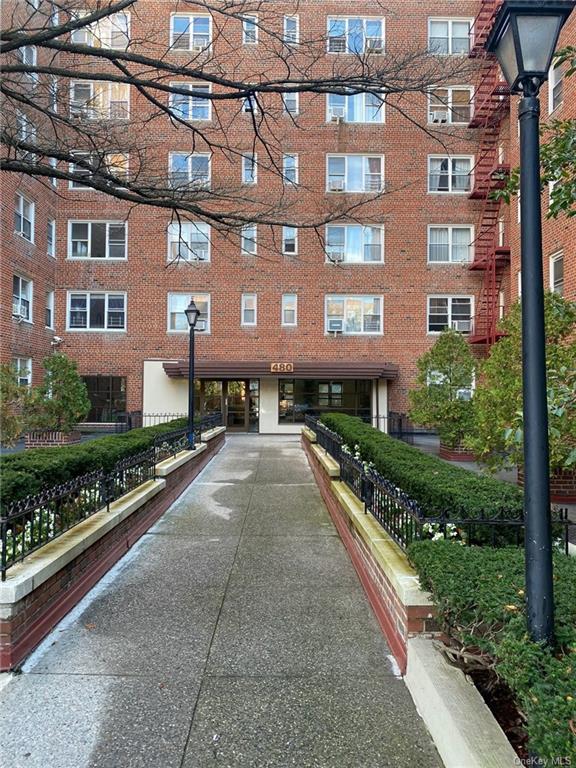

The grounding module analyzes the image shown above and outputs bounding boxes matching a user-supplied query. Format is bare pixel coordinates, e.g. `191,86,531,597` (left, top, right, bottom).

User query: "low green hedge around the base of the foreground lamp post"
408,541,576,765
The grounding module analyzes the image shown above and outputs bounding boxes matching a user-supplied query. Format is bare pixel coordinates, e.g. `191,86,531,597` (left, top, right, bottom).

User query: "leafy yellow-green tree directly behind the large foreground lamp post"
469,293,576,470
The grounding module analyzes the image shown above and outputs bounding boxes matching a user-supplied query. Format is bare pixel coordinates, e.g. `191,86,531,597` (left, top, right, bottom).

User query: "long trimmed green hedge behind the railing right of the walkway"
321,413,523,519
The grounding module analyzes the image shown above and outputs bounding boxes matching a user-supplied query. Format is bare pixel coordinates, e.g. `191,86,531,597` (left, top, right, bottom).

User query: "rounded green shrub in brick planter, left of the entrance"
24,353,90,432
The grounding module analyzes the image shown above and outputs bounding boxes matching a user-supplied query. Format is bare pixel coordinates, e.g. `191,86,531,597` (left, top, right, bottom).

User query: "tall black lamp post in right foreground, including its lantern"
486,0,576,643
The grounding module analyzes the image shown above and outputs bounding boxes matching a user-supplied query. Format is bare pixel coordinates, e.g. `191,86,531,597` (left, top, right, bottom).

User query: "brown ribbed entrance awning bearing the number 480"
164,359,398,379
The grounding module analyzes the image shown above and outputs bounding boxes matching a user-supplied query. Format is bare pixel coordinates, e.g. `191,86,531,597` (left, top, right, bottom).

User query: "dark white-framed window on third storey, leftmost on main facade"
68,221,127,259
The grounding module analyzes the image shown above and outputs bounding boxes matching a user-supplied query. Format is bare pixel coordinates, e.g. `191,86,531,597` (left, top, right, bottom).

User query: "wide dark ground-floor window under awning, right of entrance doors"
278,379,372,424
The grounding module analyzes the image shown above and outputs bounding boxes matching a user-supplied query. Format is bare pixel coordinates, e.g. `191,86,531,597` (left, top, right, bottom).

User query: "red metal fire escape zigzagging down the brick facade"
469,0,510,346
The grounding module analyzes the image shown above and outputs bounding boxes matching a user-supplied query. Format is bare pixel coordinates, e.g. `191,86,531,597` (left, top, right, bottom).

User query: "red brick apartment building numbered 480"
1,0,576,432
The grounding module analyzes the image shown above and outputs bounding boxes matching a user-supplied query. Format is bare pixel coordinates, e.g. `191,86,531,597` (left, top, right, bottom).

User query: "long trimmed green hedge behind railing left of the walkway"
0,419,186,507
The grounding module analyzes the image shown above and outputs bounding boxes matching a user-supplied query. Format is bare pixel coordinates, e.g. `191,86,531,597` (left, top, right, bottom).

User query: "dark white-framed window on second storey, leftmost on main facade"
67,291,126,331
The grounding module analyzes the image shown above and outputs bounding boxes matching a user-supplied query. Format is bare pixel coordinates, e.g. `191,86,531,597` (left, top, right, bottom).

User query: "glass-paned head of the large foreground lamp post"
486,0,576,95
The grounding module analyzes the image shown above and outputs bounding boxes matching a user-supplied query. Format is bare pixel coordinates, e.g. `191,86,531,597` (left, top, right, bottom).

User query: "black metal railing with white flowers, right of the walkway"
306,417,574,554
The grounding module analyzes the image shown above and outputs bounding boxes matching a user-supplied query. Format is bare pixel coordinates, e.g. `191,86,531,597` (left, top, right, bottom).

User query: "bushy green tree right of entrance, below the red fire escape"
410,329,476,448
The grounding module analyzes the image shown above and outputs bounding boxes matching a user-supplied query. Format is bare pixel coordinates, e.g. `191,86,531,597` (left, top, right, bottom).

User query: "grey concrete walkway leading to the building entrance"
0,436,442,768
